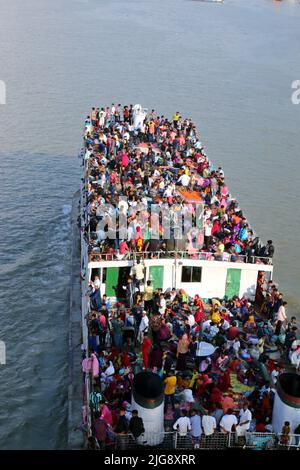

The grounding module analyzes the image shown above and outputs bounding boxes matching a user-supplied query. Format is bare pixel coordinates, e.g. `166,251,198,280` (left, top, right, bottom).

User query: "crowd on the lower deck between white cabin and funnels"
83,275,300,450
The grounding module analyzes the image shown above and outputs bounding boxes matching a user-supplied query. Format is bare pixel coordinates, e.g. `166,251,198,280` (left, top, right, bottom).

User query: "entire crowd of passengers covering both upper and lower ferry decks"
82,104,300,448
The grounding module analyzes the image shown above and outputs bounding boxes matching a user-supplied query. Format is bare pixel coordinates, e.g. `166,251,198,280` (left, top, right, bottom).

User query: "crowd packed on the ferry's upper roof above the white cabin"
84,104,274,262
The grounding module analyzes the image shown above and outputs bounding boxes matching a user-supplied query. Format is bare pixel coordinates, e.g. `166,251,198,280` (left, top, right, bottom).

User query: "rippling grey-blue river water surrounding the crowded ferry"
0,0,300,449
